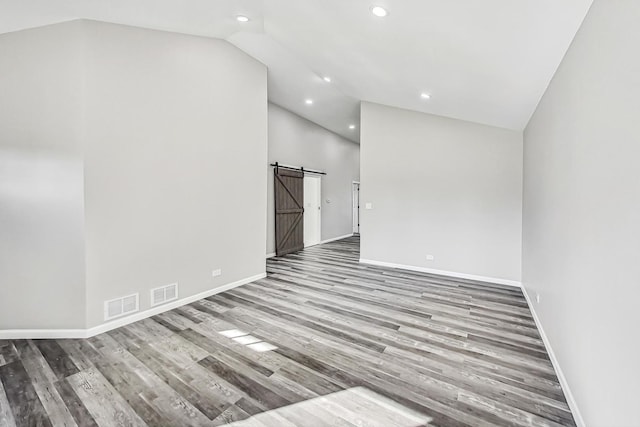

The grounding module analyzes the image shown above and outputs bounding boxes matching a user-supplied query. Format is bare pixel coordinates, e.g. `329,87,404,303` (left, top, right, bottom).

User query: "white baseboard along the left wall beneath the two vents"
0,273,267,340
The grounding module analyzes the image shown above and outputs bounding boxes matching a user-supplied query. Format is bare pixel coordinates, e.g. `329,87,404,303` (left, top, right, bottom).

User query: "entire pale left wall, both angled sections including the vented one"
0,21,267,329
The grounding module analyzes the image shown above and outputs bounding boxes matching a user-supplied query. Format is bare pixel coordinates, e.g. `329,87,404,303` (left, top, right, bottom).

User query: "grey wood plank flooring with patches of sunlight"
0,237,575,427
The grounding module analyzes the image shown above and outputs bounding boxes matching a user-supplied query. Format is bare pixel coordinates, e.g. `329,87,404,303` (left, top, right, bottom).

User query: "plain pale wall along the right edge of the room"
523,0,640,427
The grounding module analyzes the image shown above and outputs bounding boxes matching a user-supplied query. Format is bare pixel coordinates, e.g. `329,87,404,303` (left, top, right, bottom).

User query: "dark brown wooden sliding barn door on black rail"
274,168,304,256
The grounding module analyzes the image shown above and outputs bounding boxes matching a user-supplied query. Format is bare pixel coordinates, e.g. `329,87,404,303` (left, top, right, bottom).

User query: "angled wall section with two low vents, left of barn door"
85,21,267,326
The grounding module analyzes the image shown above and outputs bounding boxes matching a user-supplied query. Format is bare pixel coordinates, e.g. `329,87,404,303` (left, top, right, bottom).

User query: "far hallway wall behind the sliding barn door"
267,103,360,254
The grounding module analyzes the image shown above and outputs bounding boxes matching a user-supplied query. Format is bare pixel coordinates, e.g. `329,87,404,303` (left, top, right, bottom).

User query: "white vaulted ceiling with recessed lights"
0,0,592,141
